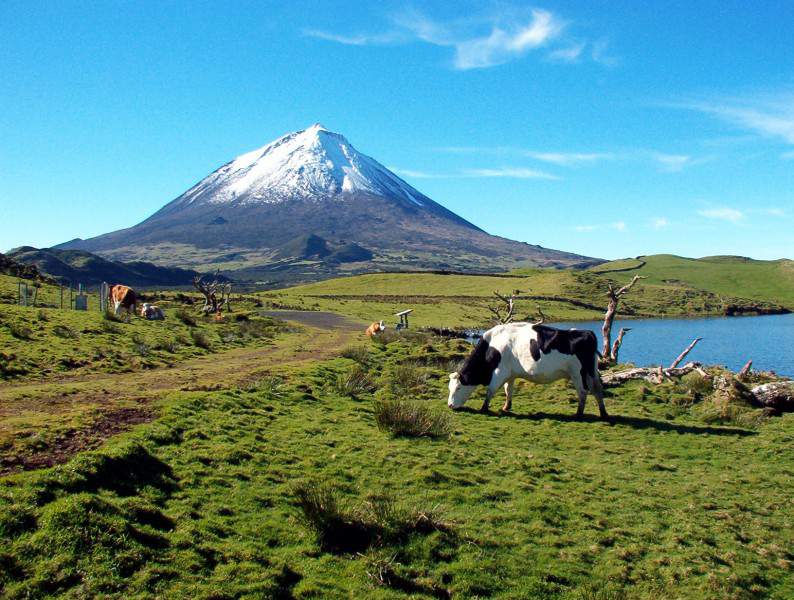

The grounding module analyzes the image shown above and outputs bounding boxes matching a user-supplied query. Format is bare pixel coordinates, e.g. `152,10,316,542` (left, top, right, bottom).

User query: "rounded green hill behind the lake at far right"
590,254,794,310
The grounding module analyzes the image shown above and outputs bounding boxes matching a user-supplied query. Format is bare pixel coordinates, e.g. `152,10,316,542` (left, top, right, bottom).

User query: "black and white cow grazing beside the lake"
447,323,609,419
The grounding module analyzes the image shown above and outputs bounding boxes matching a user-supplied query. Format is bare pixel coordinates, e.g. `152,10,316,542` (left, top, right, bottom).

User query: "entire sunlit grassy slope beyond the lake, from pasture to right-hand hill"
263,256,794,327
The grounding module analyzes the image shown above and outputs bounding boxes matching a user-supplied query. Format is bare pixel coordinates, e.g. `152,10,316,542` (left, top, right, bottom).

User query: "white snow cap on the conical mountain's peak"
175,123,424,206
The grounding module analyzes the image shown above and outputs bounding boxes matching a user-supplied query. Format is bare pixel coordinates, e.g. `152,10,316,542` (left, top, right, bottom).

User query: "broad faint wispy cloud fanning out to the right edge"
672,91,794,144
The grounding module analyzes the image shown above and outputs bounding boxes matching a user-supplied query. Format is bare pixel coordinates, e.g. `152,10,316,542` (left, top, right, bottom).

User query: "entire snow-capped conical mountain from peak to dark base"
61,125,600,279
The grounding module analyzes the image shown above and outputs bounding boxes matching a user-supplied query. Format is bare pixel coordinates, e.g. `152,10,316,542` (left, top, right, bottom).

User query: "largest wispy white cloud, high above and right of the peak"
303,8,614,71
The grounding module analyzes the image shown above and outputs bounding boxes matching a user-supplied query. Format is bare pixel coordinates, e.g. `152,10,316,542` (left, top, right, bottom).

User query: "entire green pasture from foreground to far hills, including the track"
0,257,794,600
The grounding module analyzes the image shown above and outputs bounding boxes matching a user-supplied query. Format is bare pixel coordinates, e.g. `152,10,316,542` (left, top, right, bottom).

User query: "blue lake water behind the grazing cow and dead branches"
549,314,794,377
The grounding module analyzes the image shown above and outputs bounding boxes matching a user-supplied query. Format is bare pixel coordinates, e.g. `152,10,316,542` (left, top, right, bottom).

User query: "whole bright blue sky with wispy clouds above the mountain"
0,0,794,259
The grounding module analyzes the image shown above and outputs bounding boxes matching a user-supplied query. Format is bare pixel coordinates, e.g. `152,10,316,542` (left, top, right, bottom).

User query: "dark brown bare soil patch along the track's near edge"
0,405,156,476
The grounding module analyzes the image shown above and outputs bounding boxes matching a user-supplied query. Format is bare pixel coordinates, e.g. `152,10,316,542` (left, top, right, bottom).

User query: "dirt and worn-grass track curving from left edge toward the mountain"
0,311,363,476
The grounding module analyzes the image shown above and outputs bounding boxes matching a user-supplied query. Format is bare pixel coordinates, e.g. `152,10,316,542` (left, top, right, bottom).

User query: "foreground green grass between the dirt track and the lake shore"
0,338,794,600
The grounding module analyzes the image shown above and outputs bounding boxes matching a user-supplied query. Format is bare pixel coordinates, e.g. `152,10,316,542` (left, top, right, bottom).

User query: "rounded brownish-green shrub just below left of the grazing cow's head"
375,398,452,438
